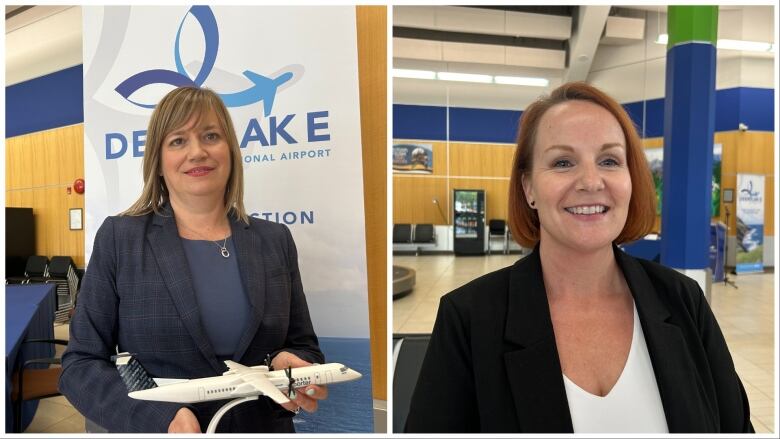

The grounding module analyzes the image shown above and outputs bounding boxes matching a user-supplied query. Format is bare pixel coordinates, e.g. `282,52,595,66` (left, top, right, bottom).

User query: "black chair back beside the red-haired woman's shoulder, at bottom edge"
393,334,430,433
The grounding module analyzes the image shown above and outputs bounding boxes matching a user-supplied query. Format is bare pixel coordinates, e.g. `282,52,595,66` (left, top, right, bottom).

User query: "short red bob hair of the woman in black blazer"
509,82,655,247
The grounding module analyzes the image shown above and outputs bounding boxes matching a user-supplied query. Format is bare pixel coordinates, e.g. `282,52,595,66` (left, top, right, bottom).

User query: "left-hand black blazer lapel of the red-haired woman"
504,246,574,433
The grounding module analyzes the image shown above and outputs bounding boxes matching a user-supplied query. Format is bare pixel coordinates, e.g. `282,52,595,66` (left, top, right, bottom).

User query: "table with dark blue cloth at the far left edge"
5,284,57,432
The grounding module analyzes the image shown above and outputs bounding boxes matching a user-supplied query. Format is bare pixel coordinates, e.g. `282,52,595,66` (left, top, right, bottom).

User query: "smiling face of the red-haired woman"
523,100,631,252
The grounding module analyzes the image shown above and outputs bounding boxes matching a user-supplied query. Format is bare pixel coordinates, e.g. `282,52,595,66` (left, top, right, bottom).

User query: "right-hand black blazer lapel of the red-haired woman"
614,247,717,433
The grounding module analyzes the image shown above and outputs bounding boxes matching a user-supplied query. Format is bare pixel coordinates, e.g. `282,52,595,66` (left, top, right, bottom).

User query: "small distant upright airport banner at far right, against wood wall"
736,174,764,274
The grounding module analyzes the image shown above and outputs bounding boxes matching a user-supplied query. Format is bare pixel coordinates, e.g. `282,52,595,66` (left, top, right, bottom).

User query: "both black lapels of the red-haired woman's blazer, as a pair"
504,246,717,432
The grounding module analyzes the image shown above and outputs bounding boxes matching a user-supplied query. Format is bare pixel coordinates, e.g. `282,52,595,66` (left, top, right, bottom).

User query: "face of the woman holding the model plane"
160,110,231,205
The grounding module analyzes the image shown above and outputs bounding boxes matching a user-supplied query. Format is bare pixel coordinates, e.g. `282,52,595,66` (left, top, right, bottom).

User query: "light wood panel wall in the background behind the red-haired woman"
393,131,777,241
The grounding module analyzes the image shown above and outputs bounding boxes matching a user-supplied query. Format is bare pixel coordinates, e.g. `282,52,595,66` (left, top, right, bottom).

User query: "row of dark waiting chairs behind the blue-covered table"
5,255,79,322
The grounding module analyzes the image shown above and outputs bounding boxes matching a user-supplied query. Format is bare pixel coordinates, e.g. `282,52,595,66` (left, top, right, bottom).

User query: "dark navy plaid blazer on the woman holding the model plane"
60,212,324,433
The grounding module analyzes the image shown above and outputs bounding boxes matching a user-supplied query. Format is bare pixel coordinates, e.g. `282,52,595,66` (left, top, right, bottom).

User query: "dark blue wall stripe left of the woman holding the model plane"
5,65,84,138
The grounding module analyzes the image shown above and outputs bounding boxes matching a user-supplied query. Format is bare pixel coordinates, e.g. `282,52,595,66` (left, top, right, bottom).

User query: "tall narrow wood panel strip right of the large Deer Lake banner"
357,6,388,401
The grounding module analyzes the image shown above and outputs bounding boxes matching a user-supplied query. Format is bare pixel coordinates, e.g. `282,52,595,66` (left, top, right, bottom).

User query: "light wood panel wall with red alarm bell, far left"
5,124,89,267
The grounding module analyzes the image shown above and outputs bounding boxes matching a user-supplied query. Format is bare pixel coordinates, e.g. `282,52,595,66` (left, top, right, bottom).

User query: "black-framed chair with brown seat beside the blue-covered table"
11,339,68,433
